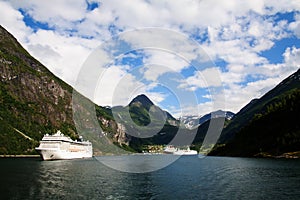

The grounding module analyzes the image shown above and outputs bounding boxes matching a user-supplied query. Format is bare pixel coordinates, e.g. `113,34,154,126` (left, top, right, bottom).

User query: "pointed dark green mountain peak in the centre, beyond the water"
112,94,179,152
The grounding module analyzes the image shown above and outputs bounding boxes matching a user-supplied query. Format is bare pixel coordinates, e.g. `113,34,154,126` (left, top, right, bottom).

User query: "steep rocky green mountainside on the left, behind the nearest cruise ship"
0,26,127,155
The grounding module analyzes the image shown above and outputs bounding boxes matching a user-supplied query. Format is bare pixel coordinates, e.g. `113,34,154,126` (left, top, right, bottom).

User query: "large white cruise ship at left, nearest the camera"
35,131,93,160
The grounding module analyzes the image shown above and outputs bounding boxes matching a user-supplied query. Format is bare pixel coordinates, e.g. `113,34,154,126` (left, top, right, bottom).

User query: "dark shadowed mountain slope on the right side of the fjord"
211,69,300,157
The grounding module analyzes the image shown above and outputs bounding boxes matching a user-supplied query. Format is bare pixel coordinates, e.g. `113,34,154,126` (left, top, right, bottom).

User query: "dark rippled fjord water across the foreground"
0,155,300,199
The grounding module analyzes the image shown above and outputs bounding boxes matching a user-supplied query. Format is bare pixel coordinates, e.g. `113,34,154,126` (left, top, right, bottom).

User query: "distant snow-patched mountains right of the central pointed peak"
180,110,234,129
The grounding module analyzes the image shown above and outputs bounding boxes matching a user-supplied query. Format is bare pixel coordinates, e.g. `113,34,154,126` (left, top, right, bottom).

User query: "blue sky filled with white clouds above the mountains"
0,0,300,117
